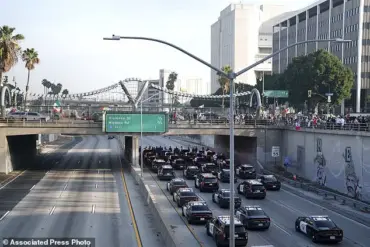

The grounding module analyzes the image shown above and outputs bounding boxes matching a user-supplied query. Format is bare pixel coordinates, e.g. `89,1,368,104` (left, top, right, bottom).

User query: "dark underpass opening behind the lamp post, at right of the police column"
214,136,257,165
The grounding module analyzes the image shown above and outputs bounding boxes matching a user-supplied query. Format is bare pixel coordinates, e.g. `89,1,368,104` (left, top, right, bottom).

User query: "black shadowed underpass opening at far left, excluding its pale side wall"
6,135,38,170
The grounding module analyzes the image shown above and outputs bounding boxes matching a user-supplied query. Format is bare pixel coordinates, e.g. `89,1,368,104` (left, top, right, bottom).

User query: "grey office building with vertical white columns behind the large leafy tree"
271,0,370,113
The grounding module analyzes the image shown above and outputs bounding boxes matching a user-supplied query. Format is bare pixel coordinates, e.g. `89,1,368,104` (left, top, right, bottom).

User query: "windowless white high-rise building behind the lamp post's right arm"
211,4,289,93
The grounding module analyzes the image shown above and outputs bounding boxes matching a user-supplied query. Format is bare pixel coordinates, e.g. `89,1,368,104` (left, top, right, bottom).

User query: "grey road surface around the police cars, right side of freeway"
143,136,370,247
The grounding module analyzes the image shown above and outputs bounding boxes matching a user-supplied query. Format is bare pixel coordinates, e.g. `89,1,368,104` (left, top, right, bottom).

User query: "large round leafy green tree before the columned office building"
280,50,354,109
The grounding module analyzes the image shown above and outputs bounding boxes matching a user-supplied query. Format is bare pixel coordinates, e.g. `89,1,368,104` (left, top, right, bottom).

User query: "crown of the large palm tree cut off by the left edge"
0,26,24,83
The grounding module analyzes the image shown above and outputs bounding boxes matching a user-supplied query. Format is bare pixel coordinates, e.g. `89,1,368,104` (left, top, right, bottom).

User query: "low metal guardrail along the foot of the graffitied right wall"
262,169,370,213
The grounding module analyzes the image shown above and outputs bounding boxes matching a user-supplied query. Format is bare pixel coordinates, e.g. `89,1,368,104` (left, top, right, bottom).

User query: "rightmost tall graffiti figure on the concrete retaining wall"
343,147,362,200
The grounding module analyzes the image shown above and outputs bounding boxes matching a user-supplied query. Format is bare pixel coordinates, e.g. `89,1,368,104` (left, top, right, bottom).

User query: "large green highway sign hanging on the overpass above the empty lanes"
103,112,168,133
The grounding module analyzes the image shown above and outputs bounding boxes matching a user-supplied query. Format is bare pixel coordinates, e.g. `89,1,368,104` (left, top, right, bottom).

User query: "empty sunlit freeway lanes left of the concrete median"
0,136,163,247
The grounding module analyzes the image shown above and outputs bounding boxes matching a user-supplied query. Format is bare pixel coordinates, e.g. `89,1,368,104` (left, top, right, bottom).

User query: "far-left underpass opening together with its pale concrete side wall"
0,134,38,173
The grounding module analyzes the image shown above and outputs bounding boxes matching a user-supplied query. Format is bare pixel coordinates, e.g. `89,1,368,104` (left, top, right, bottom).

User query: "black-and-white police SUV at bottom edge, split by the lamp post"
206,216,248,246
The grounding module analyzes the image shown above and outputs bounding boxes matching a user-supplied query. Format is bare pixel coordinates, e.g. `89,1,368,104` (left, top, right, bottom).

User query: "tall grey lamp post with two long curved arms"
103,35,352,246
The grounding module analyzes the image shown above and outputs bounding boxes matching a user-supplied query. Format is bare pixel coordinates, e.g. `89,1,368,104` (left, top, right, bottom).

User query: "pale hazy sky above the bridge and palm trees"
0,0,314,93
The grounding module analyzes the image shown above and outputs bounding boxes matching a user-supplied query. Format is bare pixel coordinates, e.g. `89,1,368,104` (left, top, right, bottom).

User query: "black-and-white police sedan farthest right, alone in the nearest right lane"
295,215,343,243
